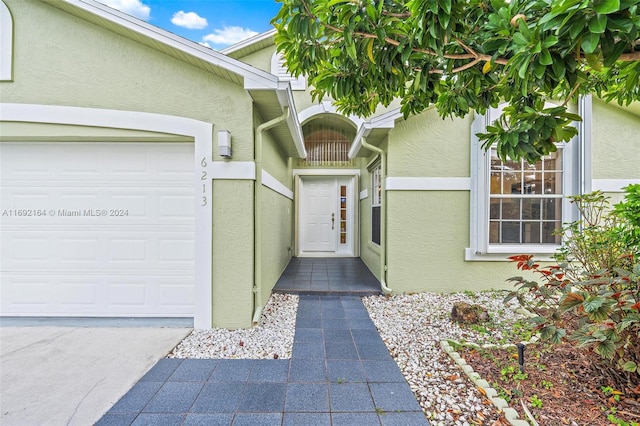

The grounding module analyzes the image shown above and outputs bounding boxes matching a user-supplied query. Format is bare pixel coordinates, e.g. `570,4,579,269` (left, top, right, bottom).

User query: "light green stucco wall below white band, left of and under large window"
387,191,518,293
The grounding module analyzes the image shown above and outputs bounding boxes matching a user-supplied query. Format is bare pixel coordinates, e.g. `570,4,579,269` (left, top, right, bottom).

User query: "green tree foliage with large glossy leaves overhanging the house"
273,0,640,162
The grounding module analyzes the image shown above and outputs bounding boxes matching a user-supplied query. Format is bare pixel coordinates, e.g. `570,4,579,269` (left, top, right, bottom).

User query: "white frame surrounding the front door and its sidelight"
293,169,360,257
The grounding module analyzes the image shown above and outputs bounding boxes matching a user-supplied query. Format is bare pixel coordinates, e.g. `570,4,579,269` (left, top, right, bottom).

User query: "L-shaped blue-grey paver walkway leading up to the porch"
98,295,429,426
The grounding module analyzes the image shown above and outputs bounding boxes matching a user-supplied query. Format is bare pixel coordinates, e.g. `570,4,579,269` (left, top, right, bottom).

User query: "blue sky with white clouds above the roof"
97,0,280,50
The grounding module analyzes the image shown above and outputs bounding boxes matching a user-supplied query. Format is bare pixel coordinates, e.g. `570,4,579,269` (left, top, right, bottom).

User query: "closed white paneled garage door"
0,142,195,317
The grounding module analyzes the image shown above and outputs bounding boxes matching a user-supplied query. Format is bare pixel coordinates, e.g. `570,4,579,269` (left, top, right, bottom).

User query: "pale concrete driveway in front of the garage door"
0,325,191,426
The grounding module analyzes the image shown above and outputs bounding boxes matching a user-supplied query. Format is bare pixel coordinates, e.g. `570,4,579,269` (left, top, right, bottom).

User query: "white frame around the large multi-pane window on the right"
465,105,590,261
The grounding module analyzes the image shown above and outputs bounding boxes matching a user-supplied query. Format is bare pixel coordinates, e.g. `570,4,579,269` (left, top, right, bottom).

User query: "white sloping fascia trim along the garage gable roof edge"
65,0,278,89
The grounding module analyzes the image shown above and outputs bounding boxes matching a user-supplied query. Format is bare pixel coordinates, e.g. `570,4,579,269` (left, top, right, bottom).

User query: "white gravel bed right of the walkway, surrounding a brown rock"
363,292,521,425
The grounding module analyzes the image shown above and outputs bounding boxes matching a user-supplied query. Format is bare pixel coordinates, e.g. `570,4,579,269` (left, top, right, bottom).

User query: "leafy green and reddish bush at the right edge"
505,185,640,386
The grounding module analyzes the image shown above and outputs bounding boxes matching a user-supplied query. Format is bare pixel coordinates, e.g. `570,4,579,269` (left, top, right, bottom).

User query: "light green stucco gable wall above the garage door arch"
0,0,253,161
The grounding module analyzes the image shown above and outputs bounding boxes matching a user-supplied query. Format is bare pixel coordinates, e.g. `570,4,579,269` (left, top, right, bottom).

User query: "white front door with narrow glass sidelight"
298,176,355,256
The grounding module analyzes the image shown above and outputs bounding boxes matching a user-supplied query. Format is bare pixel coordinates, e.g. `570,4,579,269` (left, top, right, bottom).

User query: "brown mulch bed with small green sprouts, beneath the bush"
459,342,640,426
